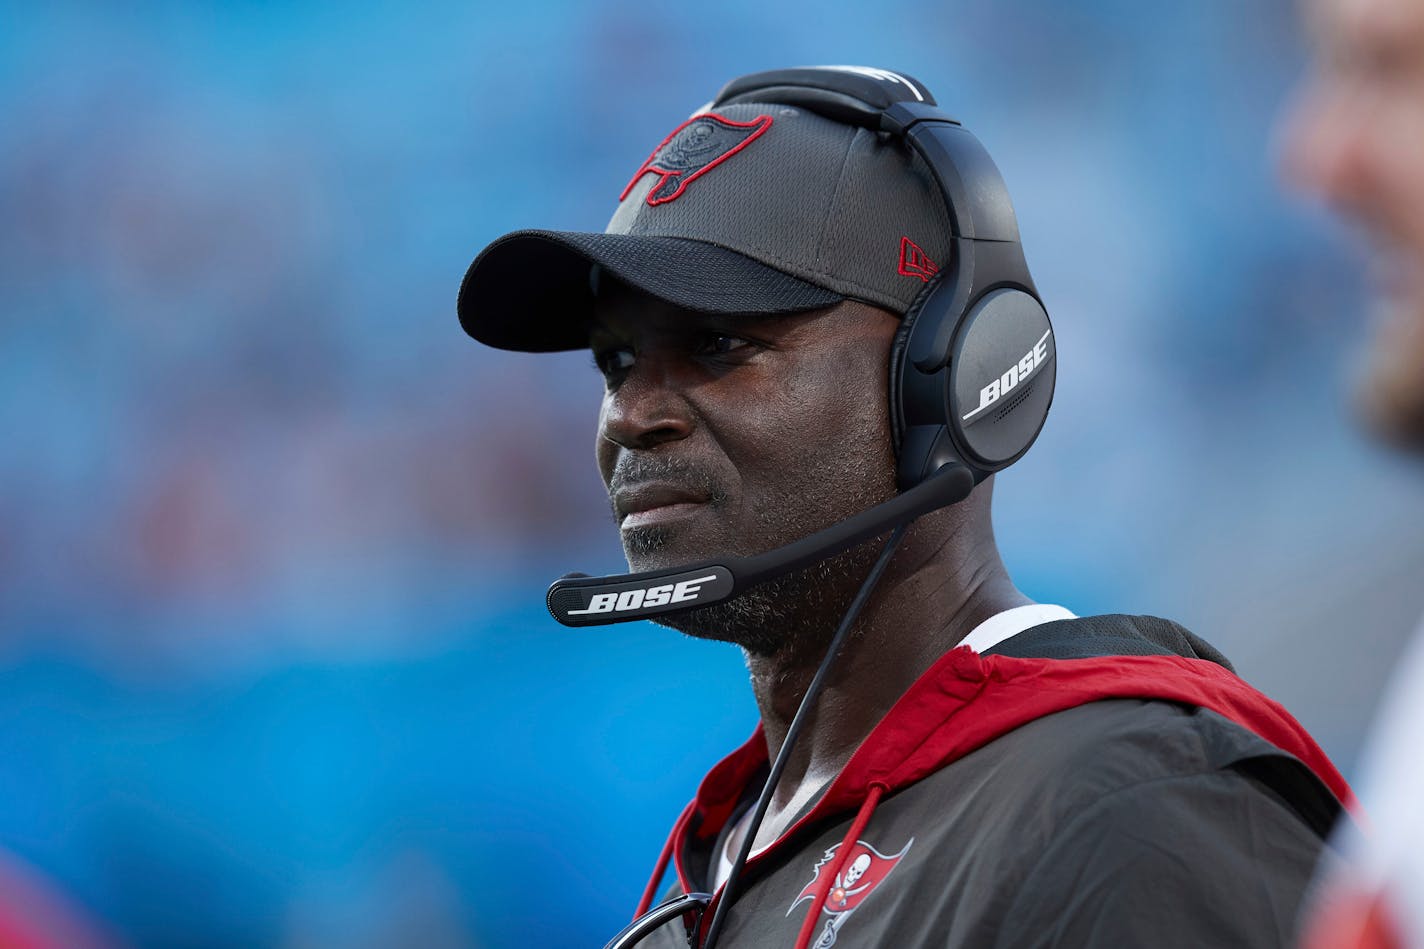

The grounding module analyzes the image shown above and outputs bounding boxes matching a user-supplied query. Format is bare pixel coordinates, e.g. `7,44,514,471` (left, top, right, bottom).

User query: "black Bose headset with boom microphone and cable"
547,67,1057,949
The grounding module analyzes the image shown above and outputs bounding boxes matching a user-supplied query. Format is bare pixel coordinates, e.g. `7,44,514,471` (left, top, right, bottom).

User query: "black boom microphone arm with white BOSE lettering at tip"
545,463,974,626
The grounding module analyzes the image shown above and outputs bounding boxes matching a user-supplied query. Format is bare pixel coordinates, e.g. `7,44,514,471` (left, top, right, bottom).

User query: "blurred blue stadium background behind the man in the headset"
0,0,1424,948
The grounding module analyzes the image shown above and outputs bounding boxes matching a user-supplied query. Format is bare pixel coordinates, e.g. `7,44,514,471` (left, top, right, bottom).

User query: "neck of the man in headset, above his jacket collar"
748,547,1031,846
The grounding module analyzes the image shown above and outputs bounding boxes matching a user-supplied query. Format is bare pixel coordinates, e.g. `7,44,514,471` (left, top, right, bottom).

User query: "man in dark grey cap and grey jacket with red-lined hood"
459,67,1347,949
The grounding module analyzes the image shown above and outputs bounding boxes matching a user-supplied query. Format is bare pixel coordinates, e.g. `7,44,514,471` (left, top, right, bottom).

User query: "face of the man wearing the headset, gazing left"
590,284,899,653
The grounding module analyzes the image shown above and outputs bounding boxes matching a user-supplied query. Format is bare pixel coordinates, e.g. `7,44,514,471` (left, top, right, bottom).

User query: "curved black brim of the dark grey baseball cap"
457,231,844,352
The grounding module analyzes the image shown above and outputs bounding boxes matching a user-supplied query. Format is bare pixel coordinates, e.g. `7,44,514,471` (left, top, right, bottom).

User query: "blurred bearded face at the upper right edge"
1284,0,1424,449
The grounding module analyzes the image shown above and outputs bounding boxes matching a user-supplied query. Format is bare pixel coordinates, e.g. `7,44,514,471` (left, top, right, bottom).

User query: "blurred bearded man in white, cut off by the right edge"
1283,0,1424,948
